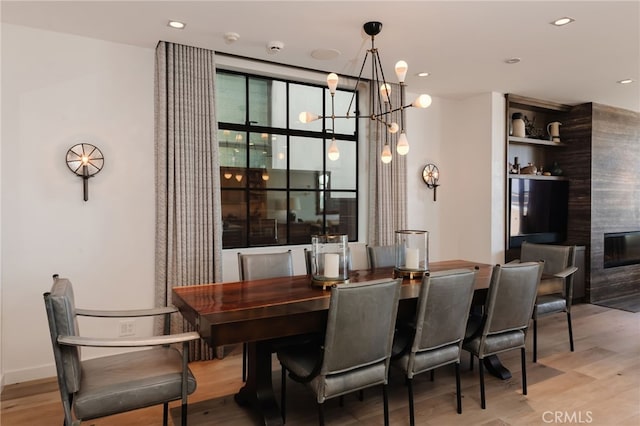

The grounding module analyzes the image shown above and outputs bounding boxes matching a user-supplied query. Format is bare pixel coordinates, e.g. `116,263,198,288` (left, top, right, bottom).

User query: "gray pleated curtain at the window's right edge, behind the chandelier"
367,84,411,245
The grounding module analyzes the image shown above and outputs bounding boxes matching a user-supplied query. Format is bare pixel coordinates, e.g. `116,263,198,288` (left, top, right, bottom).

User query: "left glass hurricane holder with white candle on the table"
310,234,349,290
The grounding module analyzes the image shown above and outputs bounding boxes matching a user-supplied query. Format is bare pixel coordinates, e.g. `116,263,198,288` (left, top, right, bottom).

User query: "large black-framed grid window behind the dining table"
216,70,358,248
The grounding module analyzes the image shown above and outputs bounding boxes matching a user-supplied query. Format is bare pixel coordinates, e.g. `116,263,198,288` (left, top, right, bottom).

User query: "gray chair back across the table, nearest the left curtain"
238,250,293,281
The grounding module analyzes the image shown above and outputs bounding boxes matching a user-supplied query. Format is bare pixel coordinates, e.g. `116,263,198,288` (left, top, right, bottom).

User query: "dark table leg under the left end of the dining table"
234,341,282,426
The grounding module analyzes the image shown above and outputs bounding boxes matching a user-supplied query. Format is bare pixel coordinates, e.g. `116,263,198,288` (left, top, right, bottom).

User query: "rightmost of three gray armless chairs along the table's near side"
462,262,543,409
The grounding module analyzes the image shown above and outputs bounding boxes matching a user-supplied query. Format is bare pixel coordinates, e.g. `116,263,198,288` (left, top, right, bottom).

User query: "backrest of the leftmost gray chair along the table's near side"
320,279,402,376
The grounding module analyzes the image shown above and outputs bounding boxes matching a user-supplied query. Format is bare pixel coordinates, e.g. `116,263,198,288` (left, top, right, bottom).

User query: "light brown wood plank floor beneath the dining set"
0,304,640,426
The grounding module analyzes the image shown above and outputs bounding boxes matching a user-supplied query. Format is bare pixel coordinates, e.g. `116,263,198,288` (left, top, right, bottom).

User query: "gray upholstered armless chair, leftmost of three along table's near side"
277,279,402,425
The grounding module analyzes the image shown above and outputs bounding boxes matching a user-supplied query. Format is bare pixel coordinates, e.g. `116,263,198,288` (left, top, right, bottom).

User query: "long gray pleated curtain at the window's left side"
155,42,222,360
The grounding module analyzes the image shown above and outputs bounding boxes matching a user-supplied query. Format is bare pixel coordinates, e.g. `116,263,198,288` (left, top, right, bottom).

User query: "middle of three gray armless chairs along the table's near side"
391,269,475,426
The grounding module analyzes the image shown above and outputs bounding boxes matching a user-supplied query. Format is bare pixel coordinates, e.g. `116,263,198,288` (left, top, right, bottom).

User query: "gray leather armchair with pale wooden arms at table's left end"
44,275,200,426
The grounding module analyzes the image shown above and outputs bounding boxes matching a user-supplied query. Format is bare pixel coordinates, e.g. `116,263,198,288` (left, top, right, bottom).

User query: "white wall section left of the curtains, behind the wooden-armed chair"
1,25,155,384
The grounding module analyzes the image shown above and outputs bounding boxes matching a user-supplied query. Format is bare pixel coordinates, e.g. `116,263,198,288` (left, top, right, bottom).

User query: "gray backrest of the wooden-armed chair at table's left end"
44,276,82,395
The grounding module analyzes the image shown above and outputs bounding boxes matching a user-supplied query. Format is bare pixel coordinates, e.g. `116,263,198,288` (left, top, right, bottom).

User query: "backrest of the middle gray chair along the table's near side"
411,269,476,353
